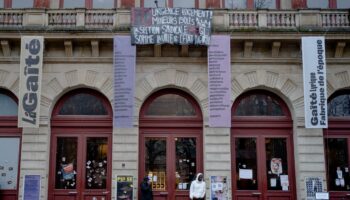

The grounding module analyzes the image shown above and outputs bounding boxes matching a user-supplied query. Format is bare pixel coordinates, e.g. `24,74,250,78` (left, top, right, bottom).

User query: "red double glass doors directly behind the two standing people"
139,134,202,200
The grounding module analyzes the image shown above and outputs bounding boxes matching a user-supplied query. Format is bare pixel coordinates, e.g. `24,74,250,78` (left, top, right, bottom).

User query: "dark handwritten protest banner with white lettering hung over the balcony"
131,8,213,45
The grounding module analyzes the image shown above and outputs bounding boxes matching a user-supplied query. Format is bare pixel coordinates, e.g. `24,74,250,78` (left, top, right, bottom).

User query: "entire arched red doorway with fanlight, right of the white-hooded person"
231,90,295,200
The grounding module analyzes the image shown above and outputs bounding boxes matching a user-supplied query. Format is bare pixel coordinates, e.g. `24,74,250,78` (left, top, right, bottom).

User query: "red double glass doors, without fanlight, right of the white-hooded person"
233,131,294,200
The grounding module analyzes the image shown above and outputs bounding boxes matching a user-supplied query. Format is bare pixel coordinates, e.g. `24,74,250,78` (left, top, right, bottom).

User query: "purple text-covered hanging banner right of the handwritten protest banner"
208,35,231,127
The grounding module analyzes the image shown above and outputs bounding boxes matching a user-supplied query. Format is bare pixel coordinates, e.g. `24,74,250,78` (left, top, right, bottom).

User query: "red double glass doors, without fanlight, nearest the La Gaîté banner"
51,135,110,200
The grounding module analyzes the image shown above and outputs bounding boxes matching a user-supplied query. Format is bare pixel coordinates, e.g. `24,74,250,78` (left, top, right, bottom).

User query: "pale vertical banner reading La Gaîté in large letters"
18,36,44,128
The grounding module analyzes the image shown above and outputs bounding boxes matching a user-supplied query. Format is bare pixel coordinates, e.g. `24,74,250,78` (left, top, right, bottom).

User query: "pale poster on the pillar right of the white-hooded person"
210,176,228,200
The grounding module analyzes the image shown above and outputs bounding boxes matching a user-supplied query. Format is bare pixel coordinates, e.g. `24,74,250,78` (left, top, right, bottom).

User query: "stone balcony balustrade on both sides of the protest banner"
0,9,350,31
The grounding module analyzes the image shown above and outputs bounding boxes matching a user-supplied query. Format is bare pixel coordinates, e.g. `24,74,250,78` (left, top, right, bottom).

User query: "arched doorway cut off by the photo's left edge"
0,89,21,200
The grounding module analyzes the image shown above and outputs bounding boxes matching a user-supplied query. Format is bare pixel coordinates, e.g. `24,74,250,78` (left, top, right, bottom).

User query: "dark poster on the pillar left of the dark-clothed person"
116,176,134,200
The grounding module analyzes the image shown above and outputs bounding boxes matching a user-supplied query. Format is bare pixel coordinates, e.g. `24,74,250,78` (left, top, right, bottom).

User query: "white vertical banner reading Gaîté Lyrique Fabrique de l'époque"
302,37,328,128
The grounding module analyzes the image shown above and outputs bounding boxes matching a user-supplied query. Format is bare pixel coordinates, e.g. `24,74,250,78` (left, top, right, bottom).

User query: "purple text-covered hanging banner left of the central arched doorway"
113,36,136,128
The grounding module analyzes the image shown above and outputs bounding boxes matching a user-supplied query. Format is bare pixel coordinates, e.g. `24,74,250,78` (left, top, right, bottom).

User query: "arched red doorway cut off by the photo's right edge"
324,89,350,199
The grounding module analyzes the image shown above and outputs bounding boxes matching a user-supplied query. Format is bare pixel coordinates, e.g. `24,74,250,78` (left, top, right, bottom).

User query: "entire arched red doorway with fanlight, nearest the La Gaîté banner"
48,89,112,200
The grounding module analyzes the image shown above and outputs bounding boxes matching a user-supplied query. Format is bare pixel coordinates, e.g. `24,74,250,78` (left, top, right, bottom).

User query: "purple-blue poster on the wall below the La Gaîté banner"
23,175,41,200
